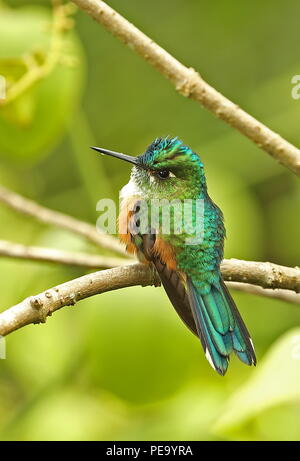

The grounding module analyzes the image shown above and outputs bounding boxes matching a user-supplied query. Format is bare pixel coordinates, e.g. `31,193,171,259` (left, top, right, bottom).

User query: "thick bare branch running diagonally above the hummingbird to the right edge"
72,0,300,176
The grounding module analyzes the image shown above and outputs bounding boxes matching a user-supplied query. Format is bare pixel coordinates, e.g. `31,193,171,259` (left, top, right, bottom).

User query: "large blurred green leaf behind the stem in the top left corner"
0,6,83,163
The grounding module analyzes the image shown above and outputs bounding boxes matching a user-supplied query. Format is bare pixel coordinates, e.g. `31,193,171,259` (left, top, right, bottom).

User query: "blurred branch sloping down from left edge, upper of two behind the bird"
0,186,128,257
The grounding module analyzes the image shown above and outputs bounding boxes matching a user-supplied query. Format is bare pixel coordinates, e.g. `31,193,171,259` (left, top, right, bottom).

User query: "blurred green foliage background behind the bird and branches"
0,0,300,440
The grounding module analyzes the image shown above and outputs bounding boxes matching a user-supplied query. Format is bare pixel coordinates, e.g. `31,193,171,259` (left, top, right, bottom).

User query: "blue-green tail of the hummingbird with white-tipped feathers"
187,279,256,375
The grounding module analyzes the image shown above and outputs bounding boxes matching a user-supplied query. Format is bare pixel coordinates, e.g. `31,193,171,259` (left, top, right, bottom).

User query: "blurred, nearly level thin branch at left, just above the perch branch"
0,240,128,269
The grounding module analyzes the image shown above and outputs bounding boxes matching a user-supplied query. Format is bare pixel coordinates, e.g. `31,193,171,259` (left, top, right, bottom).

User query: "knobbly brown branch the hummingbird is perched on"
0,260,300,336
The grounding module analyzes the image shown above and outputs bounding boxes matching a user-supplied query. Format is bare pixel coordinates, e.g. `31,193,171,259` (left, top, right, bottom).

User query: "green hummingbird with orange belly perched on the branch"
92,137,256,376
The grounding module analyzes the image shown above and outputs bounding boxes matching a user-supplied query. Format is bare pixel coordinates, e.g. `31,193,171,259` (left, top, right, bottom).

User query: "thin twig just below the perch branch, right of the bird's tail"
226,282,300,304
